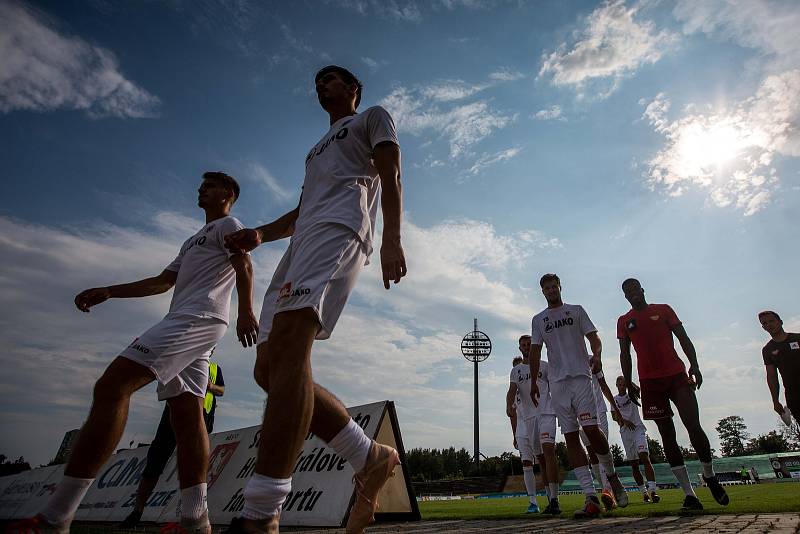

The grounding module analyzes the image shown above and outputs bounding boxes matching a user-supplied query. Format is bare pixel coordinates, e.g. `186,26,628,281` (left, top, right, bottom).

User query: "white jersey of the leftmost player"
166,215,244,324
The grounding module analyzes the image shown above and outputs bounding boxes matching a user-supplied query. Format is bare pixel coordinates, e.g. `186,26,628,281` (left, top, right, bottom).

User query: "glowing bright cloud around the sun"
644,70,800,215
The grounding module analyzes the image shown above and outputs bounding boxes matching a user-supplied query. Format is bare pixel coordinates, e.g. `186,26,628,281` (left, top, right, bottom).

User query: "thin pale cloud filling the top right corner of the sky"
673,0,800,72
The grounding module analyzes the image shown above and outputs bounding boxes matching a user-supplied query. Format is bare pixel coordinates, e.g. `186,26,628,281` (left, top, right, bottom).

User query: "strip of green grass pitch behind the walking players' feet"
419,482,800,519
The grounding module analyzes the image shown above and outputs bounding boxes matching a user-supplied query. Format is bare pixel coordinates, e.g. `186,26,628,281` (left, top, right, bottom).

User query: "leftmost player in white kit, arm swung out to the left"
24,172,258,534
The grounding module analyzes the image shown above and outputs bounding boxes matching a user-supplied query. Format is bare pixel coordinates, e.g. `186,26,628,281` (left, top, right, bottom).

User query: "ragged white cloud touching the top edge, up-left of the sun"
539,0,674,98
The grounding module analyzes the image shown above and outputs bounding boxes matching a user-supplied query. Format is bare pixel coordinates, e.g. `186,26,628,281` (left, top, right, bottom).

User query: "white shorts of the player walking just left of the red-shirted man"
550,376,597,434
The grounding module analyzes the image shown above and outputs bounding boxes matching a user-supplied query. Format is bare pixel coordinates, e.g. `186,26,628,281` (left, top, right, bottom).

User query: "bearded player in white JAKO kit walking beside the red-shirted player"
530,274,628,518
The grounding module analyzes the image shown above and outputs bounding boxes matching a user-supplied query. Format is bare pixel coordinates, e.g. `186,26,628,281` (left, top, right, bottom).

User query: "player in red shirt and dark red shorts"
617,278,729,510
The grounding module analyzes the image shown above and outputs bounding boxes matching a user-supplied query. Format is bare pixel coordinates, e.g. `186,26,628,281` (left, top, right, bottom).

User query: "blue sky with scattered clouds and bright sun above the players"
0,0,800,465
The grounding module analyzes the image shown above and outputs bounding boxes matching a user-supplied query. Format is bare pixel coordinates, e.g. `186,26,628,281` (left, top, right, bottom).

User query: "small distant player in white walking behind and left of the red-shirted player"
614,376,661,503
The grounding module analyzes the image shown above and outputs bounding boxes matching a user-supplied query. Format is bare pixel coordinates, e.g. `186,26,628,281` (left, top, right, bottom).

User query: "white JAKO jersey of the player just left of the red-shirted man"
531,304,597,382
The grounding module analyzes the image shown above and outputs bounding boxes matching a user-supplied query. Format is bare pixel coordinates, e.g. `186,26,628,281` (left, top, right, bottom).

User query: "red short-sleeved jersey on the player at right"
617,304,686,380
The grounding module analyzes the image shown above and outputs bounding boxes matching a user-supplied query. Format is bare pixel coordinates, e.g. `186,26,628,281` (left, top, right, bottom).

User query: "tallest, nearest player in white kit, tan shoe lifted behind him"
222,65,406,533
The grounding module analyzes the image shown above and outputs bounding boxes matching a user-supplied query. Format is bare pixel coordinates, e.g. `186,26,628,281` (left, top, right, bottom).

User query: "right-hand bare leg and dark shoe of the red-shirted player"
670,382,730,506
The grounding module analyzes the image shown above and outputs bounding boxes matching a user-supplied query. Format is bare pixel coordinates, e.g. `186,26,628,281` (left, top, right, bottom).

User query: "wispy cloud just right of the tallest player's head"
380,86,516,158
